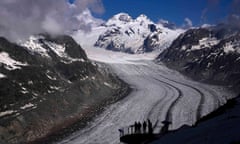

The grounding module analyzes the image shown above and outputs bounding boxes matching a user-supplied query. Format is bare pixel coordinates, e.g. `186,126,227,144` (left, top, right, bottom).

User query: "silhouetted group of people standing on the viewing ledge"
119,119,153,136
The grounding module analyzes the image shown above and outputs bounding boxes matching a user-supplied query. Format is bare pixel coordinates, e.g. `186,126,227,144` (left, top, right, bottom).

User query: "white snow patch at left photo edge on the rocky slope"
0,52,28,70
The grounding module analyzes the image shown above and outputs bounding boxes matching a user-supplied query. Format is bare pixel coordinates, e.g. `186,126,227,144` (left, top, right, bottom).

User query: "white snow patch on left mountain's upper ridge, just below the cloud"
20,36,50,57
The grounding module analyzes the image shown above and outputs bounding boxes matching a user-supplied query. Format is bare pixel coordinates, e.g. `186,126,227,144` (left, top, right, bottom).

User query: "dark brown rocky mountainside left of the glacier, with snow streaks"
0,34,128,144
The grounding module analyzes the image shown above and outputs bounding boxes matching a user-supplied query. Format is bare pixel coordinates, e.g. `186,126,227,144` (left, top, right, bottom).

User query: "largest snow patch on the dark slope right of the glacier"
191,37,219,50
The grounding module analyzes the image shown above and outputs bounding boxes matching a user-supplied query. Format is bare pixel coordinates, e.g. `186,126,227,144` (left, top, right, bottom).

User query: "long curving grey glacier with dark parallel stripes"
59,48,233,144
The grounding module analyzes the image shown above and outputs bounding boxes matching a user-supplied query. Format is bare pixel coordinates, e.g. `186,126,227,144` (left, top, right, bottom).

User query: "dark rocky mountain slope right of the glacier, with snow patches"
157,24,240,91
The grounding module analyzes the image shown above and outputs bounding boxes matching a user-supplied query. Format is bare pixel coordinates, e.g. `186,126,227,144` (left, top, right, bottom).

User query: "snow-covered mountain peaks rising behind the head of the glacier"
73,13,183,54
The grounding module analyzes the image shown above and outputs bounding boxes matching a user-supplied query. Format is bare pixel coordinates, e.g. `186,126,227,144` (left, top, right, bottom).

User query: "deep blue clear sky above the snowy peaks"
70,0,234,26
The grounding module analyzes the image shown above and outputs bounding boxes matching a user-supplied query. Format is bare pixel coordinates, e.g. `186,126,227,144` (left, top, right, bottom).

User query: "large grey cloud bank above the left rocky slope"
0,0,104,41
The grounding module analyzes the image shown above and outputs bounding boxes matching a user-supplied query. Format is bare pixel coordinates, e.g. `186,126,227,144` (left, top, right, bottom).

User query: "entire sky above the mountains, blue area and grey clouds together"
0,0,240,41
